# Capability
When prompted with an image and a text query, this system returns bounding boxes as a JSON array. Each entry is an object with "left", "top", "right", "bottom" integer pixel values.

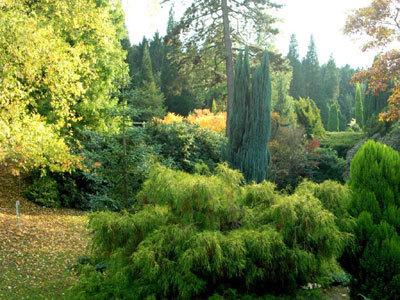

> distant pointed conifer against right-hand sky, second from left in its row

[{"left": 303, "top": 35, "right": 328, "bottom": 125}]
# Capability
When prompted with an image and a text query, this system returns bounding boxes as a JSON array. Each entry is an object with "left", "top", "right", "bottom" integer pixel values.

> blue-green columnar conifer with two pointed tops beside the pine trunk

[{"left": 228, "top": 47, "right": 271, "bottom": 182}]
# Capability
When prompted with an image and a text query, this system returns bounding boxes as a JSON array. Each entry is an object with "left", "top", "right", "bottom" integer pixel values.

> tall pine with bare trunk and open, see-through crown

[{"left": 162, "top": 0, "right": 280, "bottom": 134}]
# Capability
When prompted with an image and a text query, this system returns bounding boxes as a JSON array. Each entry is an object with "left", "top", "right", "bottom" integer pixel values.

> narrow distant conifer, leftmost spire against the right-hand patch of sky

[{"left": 287, "top": 34, "right": 305, "bottom": 99}]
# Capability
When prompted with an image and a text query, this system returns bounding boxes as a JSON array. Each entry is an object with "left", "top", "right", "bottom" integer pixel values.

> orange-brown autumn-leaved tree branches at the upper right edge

[{"left": 344, "top": 0, "right": 400, "bottom": 121}]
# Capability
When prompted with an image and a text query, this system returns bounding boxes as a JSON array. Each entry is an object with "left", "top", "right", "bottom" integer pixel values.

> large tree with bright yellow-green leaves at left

[{"left": 0, "top": 0, "right": 127, "bottom": 173}]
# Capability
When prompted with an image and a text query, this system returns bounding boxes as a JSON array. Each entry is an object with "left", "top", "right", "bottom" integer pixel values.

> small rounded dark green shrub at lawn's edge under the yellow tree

[{"left": 25, "top": 176, "right": 61, "bottom": 207}]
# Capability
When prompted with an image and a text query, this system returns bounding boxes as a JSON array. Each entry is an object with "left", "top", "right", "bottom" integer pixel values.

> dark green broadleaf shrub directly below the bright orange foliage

[{"left": 146, "top": 122, "right": 226, "bottom": 173}]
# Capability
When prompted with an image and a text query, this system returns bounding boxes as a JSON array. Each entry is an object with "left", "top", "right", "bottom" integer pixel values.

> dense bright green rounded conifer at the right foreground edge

[{"left": 342, "top": 141, "right": 400, "bottom": 299}]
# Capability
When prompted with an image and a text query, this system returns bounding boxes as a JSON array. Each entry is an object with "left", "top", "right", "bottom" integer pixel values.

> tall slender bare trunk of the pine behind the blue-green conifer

[{"left": 221, "top": 0, "right": 234, "bottom": 138}]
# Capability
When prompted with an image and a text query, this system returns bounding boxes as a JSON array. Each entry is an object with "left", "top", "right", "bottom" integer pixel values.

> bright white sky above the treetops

[{"left": 123, "top": 0, "right": 377, "bottom": 68}]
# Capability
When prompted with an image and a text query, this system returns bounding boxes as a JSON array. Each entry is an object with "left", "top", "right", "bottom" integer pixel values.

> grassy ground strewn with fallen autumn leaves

[{"left": 0, "top": 169, "right": 89, "bottom": 300}]
